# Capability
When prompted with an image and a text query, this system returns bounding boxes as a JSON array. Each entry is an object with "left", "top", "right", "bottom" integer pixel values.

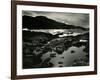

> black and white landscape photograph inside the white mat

[{"left": 22, "top": 10, "right": 90, "bottom": 69}]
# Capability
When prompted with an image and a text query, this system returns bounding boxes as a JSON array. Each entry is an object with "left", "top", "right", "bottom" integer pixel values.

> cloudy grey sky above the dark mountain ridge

[{"left": 22, "top": 11, "right": 89, "bottom": 28}]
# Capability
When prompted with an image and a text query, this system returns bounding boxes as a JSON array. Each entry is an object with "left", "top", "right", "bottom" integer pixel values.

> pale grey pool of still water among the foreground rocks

[{"left": 41, "top": 46, "right": 87, "bottom": 67}]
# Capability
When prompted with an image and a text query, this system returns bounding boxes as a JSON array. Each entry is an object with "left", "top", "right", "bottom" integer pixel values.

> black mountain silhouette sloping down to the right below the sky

[{"left": 22, "top": 15, "right": 87, "bottom": 30}]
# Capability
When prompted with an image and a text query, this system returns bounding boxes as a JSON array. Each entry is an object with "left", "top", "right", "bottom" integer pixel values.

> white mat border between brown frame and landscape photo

[{"left": 17, "top": 5, "right": 94, "bottom": 75}]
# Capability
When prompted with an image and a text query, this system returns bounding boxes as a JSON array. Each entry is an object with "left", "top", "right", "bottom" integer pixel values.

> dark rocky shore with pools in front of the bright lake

[{"left": 23, "top": 31, "right": 89, "bottom": 68}]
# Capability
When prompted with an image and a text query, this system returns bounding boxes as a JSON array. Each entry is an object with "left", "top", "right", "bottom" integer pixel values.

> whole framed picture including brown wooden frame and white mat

[{"left": 11, "top": 1, "right": 97, "bottom": 79}]
